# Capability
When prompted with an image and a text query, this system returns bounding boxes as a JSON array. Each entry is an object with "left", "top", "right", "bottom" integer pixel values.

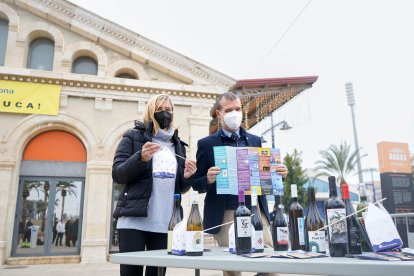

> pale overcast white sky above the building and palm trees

[{"left": 71, "top": 0, "right": 414, "bottom": 184}]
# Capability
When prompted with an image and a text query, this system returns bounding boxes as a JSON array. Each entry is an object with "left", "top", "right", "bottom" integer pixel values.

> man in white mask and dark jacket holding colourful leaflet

[{"left": 193, "top": 92, "right": 287, "bottom": 276}]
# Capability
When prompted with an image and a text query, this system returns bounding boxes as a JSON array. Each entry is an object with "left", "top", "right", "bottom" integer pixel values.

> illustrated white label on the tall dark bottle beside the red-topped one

[{"left": 326, "top": 208, "right": 348, "bottom": 243}]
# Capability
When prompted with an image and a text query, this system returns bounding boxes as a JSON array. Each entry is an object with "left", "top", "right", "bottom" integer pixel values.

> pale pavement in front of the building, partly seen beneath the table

[{"left": 0, "top": 262, "right": 310, "bottom": 276}]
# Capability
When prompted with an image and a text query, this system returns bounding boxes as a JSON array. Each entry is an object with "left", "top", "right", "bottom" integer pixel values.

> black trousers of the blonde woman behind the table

[{"left": 118, "top": 229, "right": 168, "bottom": 276}]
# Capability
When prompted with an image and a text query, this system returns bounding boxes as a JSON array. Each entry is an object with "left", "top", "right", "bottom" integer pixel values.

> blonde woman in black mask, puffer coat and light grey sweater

[{"left": 112, "top": 94, "right": 197, "bottom": 276}]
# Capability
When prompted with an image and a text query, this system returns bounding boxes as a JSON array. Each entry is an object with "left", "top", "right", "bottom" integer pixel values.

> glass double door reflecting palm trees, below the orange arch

[{"left": 12, "top": 177, "right": 84, "bottom": 256}]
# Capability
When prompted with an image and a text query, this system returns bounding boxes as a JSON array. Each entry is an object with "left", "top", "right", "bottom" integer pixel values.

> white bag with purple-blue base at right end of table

[{"left": 365, "top": 203, "right": 403, "bottom": 252}]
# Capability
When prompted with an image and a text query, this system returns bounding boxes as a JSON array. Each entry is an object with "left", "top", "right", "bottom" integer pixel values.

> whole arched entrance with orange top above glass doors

[{"left": 11, "top": 130, "right": 87, "bottom": 257}]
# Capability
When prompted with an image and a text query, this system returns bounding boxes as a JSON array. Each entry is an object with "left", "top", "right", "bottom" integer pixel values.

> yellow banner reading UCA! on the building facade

[{"left": 0, "top": 81, "right": 60, "bottom": 115}]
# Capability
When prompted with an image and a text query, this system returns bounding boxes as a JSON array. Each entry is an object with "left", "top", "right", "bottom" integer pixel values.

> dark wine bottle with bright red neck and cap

[{"left": 341, "top": 183, "right": 362, "bottom": 254}]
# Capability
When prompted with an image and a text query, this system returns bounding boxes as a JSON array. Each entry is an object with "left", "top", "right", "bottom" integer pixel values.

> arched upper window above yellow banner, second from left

[{"left": 27, "top": 38, "right": 55, "bottom": 71}]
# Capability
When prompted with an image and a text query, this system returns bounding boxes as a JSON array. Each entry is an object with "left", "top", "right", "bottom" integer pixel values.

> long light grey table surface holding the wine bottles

[{"left": 111, "top": 248, "right": 414, "bottom": 276}]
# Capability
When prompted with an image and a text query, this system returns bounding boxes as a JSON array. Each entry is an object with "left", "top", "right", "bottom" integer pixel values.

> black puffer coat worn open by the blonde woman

[{"left": 112, "top": 121, "right": 192, "bottom": 218}]
